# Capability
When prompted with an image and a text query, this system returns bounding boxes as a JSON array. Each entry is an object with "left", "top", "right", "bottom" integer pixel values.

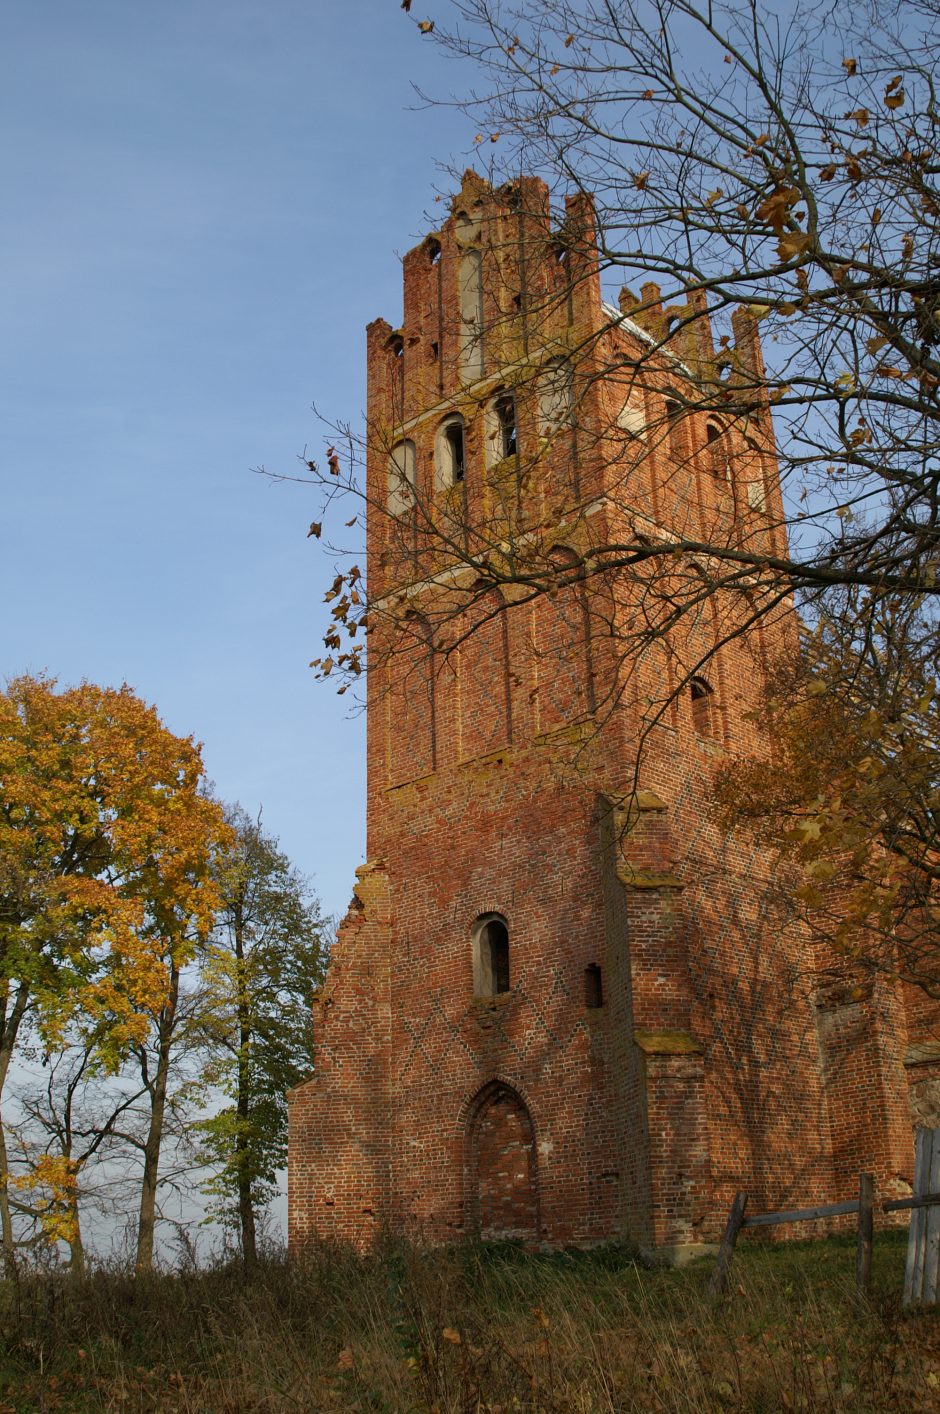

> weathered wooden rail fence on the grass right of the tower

[{"left": 711, "top": 1128, "right": 940, "bottom": 1302}]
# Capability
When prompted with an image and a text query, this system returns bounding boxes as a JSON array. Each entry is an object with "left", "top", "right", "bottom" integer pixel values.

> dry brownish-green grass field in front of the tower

[{"left": 0, "top": 1233, "right": 940, "bottom": 1414}]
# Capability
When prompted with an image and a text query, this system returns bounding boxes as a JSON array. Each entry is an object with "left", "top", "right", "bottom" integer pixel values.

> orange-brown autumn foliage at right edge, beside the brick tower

[{"left": 715, "top": 598, "right": 940, "bottom": 998}]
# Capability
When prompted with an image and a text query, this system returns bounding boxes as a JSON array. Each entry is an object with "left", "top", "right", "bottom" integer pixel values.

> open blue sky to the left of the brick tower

[{"left": 0, "top": 0, "right": 472, "bottom": 913}]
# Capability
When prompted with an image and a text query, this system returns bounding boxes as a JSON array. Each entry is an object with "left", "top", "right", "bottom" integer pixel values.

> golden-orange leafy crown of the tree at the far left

[{"left": 0, "top": 676, "right": 228, "bottom": 1270}]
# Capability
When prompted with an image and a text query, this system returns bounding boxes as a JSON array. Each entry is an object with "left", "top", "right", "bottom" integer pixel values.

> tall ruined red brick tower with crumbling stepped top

[{"left": 290, "top": 173, "right": 932, "bottom": 1251}]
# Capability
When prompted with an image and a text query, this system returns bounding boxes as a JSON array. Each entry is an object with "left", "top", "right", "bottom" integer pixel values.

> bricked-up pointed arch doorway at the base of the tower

[{"left": 468, "top": 1080, "right": 539, "bottom": 1241}]
